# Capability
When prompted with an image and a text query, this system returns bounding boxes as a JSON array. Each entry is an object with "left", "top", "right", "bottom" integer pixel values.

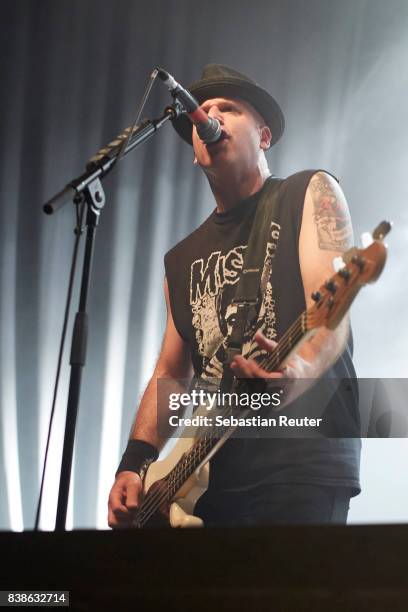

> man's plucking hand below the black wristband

[{"left": 108, "top": 471, "right": 143, "bottom": 529}]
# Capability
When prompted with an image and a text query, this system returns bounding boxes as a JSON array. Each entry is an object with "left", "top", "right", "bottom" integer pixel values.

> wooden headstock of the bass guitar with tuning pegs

[{"left": 306, "top": 221, "right": 391, "bottom": 330}]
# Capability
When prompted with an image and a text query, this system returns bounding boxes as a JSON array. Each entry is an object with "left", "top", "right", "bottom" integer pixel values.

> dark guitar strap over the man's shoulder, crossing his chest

[{"left": 220, "top": 177, "right": 282, "bottom": 393}]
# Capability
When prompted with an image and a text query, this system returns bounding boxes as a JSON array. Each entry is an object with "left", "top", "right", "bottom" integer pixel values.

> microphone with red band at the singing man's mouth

[{"left": 157, "top": 68, "right": 222, "bottom": 144}]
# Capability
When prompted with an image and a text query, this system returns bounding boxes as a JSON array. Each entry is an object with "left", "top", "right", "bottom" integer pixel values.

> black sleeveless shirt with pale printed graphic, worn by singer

[{"left": 165, "top": 170, "right": 361, "bottom": 494}]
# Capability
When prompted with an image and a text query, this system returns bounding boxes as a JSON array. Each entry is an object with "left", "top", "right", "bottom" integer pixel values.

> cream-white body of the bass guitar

[{"left": 144, "top": 438, "right": 209, "bottom": 527}]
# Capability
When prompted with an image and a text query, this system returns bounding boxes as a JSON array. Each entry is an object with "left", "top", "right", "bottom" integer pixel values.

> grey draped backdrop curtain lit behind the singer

[{"left": 0, "top": 0, "right": 408, "bottom": 529}]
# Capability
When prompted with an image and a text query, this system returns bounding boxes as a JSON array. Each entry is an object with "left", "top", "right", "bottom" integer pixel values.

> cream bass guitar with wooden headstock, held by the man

[{"left": 134, "top": 221, "right": 391, "bottom": 528}]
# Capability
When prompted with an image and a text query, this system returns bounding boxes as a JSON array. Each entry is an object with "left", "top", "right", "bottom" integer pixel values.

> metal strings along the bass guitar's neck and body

[{"left": 137, "top": 311, "right": 307, "bottom": 522}]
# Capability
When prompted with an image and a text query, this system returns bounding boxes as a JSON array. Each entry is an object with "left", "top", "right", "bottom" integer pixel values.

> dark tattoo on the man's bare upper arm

[{"left": 309, "top": 173, "right": 353, "bottom": 251}]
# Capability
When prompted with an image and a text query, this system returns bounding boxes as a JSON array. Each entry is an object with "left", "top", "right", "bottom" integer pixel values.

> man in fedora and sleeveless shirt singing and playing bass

[{"left": 108, "top": 64, "right": 360, "bottom": 528}]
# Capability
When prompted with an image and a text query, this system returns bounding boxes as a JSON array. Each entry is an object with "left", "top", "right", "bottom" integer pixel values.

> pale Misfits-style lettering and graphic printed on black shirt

[{"left": 190, "top": 222, "right": 280, "bottom": 378}]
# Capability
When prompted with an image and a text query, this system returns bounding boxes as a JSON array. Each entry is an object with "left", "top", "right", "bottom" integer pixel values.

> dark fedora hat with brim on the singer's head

[{"left": 173, "top": 64, "right": 285, "bottom": 146}]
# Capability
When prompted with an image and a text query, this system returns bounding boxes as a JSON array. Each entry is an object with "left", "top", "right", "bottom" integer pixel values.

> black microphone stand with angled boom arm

[{"left": 43, "top": 100, "right": 184, "bottom": 531}]
